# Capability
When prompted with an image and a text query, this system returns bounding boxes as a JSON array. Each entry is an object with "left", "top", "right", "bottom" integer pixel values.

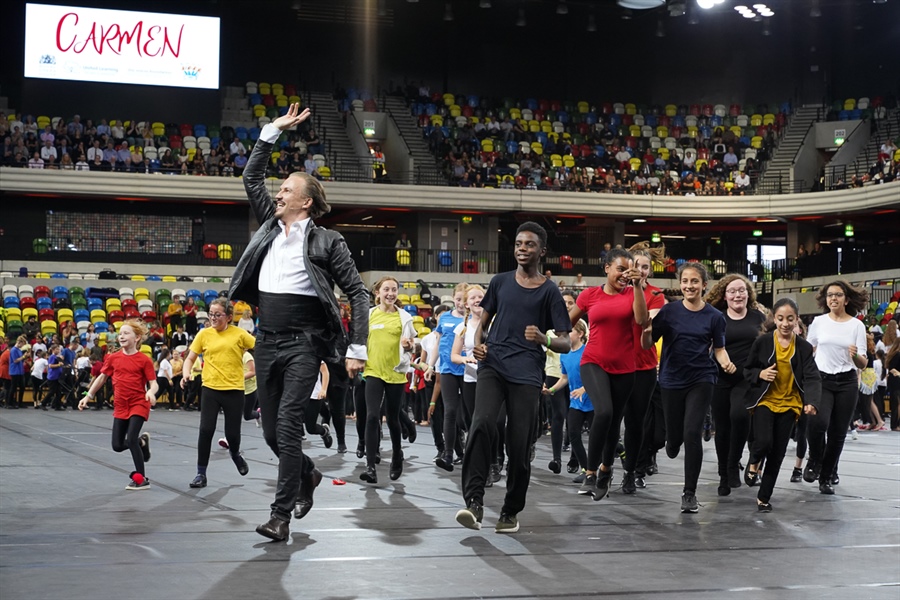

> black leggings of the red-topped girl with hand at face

[{"left": 581, "top": 363, "right": 634, "bottom": 471}]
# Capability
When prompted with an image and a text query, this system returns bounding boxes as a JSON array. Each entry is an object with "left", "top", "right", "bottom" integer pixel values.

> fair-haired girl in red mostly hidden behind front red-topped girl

[{"left": 622, "top": 242, "right": 666, "bottom": 494}]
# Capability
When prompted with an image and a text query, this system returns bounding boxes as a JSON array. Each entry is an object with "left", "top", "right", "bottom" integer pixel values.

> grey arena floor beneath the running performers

[{"left": 0, "top": 408, "right": 900, "bottom": 600}]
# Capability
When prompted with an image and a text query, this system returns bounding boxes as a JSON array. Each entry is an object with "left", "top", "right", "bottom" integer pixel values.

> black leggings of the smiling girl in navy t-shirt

[{"left": 662, "top": 383, "right": 713, "bottom": 492}]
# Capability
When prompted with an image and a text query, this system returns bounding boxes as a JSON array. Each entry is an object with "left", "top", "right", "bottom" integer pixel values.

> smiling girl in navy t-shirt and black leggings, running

[{"left": 641, "top": 262, "right": 737, "bottom": 513}]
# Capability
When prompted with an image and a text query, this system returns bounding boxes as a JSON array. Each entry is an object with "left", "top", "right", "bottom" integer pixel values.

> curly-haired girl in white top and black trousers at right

[{"left": 803, "top": 280, "right": 869, "bottom": 494}]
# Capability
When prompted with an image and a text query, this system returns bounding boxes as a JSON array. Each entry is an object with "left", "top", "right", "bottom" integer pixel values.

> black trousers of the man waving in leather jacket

[{"left": 254, "top": 331, "right": 325, "bottom": 521}]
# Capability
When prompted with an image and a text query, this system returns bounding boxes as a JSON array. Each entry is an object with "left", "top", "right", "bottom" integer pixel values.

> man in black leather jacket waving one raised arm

[{"left": 229, "top": 104, "right": 369, "bottom": 541}]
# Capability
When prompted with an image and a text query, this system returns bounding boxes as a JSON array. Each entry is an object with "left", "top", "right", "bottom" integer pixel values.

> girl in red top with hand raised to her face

[{"left": 569, "top": 248, "right": 648, "bottom": 500}]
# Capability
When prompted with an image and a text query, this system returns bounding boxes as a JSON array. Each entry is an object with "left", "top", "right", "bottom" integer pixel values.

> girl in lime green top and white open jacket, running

[{"left": 357, "top": 277, "right": 416, "bottom": 483}]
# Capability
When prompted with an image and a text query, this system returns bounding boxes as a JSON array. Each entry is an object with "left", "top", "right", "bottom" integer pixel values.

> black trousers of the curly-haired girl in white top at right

[{"left": 809, "top": 373, "right": 858, "bottom": 483}]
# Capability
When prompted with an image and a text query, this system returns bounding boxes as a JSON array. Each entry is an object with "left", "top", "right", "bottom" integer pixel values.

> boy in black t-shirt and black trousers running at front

[{"left": 456, "top": 221, "right": 572, "bottom": 533}]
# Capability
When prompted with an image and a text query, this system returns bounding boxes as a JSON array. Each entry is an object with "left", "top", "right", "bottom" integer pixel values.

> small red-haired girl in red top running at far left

[{"left": 78, "top": 319, "right": 159, "bottom": 490}]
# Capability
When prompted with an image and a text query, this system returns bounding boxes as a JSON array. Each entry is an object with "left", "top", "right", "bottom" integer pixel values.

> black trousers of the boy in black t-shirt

[{"left": 462, "top": 366, "right": 541, "bottom": 515}]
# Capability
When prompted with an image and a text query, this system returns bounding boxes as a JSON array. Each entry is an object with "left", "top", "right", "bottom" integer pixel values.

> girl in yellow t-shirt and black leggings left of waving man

[{"left": 181, "top": 298, "right": 256, "bottom": 488}]
